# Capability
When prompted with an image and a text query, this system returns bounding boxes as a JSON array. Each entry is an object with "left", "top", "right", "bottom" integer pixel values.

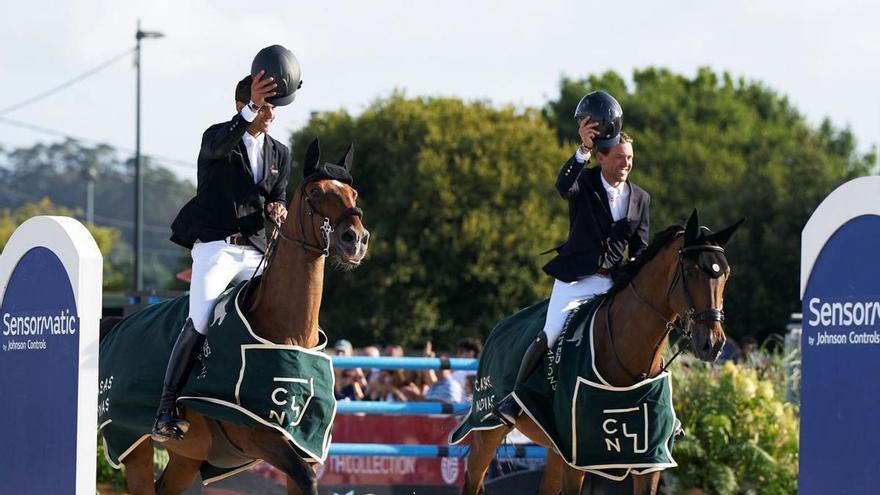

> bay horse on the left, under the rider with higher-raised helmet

[{"left": 102, "top": 140, "right": 369, "bottom": 495}]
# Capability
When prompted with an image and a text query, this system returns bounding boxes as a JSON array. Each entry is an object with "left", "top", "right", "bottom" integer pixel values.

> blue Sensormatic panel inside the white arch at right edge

[{"left": 798, "top": 215, "right": 880, "bottom": 495}]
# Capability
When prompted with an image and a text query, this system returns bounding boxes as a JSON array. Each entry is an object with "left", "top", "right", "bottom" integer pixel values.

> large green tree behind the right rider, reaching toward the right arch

[{"left": 543, "top": 68, "right": 873, "bottom": 337}]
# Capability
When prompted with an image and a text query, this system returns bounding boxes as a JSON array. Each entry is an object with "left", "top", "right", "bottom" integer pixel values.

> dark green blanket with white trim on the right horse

[{"left": 450, "top": 297, "right": 679, "bottom": 480}]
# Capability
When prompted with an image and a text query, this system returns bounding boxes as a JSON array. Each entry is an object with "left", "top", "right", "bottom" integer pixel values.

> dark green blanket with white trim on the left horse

[{"left": 98, "top": 283, "right": 336, "bottom": 480}]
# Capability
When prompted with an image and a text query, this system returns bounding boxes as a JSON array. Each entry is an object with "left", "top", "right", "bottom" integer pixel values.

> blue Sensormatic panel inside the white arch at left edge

[{"left": 0, "top": 247, "right": 80, "bottom": 495}]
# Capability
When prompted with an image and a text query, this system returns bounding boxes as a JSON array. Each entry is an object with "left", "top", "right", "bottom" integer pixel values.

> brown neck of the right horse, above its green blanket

[{"left": 593, "top": 240, "right": 680, "bottom": 386}]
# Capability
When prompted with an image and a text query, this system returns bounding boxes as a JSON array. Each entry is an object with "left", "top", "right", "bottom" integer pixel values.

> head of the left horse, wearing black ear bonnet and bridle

[{"left": 281, "top": 139, "right": 370, "bottom": 268}]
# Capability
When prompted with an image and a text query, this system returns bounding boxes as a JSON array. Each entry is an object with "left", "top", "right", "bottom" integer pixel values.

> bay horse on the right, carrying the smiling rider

[{"left": 462, "top": 210, "right": 743, "bottom": 495}]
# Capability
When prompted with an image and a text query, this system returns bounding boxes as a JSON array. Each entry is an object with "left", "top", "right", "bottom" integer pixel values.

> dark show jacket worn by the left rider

[{"left": 171, "top": 113, "right": 290, "bottom": 251}]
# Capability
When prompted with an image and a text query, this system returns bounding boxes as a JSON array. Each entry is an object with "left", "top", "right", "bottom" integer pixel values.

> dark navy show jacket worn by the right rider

[{"left": 544, "top": 156, "right": 651, "bottom": 282}]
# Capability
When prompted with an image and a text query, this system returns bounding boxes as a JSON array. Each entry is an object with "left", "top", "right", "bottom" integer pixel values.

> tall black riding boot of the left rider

[{"left": 150, "top": 318, "right": 205, "bottom": 442}]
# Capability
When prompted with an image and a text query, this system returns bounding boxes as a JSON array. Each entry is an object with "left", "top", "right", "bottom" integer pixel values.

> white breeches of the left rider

[{"left": 189, "top": 240, "right": 263, "bottom": 335}]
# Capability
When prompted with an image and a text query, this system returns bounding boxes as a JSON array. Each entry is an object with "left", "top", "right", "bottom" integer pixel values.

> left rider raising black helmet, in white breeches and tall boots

[{"left": 151, "top": 45, "right": 301, "bottom": 442}]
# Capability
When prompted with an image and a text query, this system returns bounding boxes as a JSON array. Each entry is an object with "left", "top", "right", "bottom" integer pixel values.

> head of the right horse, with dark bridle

[{"left": 670, "top": 210, "right": 743, "bottom": 361}]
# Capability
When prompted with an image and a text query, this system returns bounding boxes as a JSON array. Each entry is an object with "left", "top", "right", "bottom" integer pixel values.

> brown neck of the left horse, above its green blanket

[{"left": 248, "top": 203, "right": 324, "bottom": 348}]
